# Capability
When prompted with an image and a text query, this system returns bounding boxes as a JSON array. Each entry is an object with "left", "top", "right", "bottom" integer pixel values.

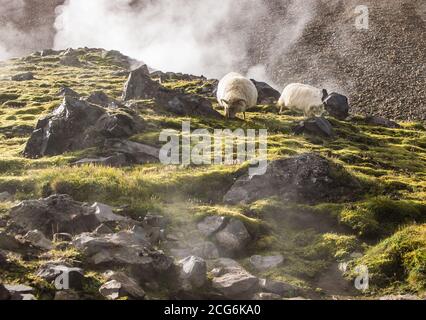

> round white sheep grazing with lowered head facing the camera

[{"left": 217, "top": 72, "right": 258, "bottom": 120}]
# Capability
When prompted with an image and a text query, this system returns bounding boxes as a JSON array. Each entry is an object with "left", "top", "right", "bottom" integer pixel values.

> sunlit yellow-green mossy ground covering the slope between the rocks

[{"left": 0, "top": 50, "right": 426, "bottom": 294}]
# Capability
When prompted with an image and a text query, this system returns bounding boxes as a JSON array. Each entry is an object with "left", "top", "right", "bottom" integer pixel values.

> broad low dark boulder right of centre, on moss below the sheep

[{"left": 224, "top": 153, "right": 360, "bottom": 204}]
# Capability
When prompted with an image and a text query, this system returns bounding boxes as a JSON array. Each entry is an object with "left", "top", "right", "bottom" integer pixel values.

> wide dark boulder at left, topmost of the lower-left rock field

[{"left": 10, "top": 195, "right": 101, "bottom": 239}]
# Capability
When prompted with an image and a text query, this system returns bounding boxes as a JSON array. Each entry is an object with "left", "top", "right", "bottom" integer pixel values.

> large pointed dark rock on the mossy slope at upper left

[{"left": 24, "top": 96, "right": 143, "bottom": 158}]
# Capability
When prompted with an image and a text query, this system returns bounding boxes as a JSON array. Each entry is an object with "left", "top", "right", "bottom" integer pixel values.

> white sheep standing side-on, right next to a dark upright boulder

[{"left": 278, "top": 83, "right": 328, "bottom": 117}]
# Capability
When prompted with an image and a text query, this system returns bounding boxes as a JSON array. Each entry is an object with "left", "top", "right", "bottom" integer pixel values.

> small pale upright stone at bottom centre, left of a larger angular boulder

[{"left": 179, "top": 256, "right": 207, "bottom": 289}]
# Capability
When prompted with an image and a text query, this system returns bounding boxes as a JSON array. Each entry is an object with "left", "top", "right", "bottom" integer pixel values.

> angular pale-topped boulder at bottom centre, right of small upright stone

[{"left": 212, "top": 259, "right": 259, "bottom": 299}]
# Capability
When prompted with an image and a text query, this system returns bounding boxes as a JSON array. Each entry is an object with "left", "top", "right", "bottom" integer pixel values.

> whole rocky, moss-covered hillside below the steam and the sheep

[{"left": 0, "top": 48, "right": 426, "bottom": 299}]
